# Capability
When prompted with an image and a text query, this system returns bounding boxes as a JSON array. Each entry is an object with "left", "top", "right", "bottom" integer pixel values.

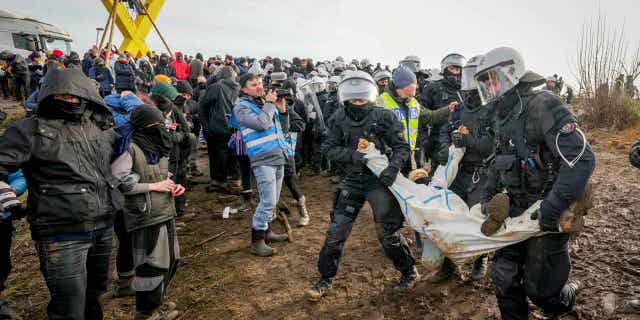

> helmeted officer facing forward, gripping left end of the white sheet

[{"left": 306, "top": 71, "right": 420, "bottom": 301}]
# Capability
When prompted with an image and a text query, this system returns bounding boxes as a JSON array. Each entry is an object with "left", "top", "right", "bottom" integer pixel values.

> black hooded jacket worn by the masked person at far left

[{"left": 0, "top": 68, "right": 123, "bottom": 239}]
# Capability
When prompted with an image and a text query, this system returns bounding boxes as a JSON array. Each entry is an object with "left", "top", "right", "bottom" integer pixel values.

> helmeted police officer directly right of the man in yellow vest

[{"left": 421, "top": 53, "right": 466, "bottom": 173}]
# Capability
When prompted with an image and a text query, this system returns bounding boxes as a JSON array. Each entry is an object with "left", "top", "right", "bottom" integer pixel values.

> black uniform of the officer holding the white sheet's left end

[{"left": 318, "top": 107, "right": 415, "bottom": 281}]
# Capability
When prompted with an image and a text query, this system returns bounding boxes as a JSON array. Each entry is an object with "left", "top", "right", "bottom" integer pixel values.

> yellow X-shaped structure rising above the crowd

[{"left": 101, "top": 0, "right": 164, "bottom": 58}]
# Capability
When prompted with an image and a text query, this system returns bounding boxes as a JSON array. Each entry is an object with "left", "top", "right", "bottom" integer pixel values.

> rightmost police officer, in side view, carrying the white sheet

[{"left": 475, "top": 47, "right": 595, "bottom": 320}]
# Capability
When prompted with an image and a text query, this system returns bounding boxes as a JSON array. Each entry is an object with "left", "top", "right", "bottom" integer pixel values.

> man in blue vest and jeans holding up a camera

[{"left": 230, "top": 74, "right": 293, "bottom": 257}]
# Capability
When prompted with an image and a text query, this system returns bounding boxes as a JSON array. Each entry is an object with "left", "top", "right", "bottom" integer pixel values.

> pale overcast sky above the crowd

[{"left": 2, "top": 0, "right": 640, "bottom": 85}]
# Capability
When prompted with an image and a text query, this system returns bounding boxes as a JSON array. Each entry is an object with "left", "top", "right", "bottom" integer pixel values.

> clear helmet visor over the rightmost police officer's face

[{"left": 475, "top": 65, "right": 517, "bottom": 105}]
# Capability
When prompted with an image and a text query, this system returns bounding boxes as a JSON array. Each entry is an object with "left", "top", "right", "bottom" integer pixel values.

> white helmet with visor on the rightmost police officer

[{"left": 475, "top": 47, "right": 544, "bottom": 104}]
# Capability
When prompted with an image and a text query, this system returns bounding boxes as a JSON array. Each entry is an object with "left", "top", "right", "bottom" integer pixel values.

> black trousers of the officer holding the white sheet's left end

[{"left": 318, "top": 175, "right": 415, "bottom": 281}]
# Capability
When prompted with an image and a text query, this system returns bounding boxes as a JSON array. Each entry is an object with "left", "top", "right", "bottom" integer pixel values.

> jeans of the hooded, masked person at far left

[{"left": 36, "top": 228, "right": 113, "bottom": 320}]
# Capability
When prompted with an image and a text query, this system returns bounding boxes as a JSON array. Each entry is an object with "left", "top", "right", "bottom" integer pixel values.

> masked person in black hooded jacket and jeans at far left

[{"left": 0, "top": 68, "right": 123, "bottom": 319}]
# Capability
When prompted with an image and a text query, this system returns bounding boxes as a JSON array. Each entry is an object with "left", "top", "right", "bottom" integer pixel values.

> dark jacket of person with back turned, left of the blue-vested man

[{"left": 200, "top": 79, "right": 240, "bottom": 134}]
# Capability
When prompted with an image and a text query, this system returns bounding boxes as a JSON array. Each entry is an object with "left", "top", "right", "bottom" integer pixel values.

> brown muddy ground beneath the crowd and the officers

[{"left": 0, "top": 98, "right": 640, "bottom": 320}]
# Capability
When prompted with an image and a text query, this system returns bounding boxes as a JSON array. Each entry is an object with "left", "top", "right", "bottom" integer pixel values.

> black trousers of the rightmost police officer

[{"left": 492, "top": 234, "right": 571, "bottom": 320}]
